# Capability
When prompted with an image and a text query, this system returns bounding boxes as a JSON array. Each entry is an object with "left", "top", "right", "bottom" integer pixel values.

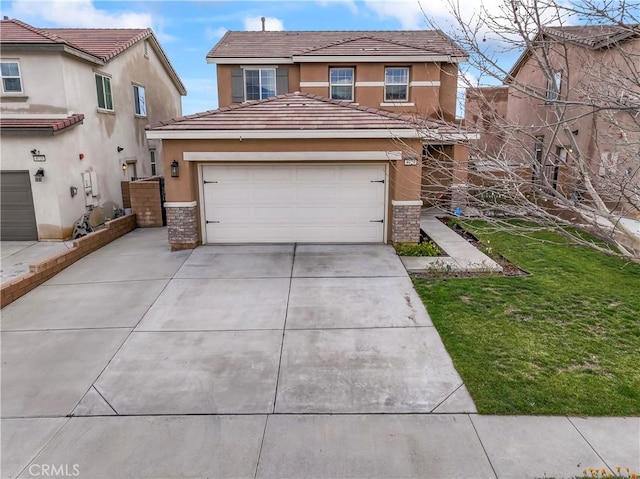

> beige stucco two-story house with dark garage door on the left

[{"left": 0, "top": 18, "right": 186, "bottom": 240}]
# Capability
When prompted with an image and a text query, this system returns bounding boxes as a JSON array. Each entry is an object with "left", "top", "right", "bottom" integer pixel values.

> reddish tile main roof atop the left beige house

[{"left": 0, "top": 19, "right": 153, "bottom": 62}]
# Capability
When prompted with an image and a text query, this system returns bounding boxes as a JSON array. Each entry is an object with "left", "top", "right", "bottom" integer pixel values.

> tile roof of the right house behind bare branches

[{"left": 541, "top": 25, "right": 640, "bottom": 49}]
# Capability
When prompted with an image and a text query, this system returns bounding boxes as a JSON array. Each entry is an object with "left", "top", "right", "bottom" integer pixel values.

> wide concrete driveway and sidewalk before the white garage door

[{"left": 1, "top": 229, "right": 637, "bottom": 478}]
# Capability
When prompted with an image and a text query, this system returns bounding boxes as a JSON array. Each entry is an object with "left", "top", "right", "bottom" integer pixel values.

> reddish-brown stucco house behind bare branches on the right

[{"left": 466, "top": 25, "right": 640, "bottom": 215}]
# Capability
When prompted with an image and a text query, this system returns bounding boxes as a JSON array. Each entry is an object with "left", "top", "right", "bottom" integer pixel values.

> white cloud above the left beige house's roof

[{"left": 11, "top": 0, "right": 153, "bottom": 28}]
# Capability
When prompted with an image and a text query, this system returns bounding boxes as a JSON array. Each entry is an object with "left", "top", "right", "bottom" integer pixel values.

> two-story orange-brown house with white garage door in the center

[{"left": 147, "top": 31, "right": 467, "bottom": 249}]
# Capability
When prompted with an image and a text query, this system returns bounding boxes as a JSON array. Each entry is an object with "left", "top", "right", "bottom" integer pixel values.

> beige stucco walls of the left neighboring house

[{"left": 0, "top": 38, "right": 181, "bottom": 239}]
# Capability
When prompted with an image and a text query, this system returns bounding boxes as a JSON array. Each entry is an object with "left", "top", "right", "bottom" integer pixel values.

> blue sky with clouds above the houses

[{"left": 5, "top": 0, "right": 540, "bottom": 115}]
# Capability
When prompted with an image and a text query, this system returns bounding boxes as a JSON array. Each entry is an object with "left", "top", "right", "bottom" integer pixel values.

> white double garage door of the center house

[{"left": 202, "top": 164, "right": 386, "bottom": 243}]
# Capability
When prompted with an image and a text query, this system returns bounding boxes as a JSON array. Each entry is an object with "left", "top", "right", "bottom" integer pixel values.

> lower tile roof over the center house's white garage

[{"left": 147, "top": 92, "right": 460, "bottom": 138}]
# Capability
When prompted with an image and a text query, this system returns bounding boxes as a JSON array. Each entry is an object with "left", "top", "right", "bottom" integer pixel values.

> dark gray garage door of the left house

[{"left": 0, "top": 171, "right": 38, "bottom": 241}]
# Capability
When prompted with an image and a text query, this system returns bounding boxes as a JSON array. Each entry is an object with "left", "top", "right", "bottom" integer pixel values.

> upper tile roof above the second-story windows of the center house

[{"left": 207, "top": 30, "right": 467, "bottom": 59}]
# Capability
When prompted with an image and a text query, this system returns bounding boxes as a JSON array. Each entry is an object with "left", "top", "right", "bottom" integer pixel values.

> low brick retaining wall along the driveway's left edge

[{"left": 0, "top": 215, "right": 136, "bottom": 308}]
